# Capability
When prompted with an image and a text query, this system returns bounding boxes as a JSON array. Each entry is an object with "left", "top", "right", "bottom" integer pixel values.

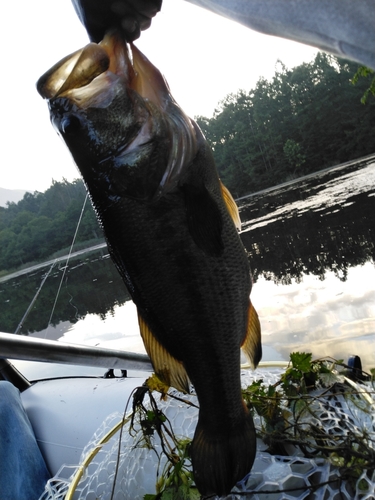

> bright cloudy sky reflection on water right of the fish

[{"left": 253, "top": 262, "right": 375, "bottom": 369}]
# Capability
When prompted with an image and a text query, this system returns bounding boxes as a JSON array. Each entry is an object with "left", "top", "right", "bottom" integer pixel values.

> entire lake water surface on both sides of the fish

[{"left": 0, "top": 156, "right": 375, "bottom": 370}]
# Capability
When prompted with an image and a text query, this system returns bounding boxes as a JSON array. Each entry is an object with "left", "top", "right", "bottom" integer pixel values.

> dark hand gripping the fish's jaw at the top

[{"left": 72, "top": 0, "right": 162, "bottom": 43}]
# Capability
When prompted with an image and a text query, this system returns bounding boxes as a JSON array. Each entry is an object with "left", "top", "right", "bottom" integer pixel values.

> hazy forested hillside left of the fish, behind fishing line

[{"left": 0, "top": 179, "right": 103, "bottom": 270}]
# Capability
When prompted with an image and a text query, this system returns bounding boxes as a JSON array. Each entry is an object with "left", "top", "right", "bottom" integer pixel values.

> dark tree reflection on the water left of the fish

[{"left": 0, "top": 254, "right": 130, "bottom": 338}]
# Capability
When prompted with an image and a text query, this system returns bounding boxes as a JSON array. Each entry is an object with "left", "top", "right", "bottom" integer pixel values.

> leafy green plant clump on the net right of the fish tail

[{"left": 243, "top": 352, "right": 375, "bottom": 484}]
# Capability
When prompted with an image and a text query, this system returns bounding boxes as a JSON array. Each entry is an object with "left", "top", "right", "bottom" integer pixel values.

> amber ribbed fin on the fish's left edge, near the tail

[{"left": 138, "top": 311, "right": 190, "bottom": 393}]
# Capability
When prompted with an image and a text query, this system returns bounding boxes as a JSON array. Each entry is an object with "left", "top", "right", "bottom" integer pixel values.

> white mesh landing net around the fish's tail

[{"left": 40, "top": 369, "right": 375, "bottom": 500}]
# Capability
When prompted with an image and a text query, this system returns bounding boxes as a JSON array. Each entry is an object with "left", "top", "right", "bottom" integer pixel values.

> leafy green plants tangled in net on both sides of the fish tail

[{"left": 130, "top": 352, "right": 375, "bottom": 500}]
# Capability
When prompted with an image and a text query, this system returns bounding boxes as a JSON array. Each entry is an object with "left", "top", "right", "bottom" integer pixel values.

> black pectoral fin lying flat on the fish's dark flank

[{"left": 181, "top": 183, "right": 224, "bottom": 255}]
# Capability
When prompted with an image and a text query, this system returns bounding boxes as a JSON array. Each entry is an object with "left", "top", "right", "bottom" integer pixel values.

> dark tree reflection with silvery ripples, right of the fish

[{"left": 241, "top": 159, "right": 375, "bottom": 284}]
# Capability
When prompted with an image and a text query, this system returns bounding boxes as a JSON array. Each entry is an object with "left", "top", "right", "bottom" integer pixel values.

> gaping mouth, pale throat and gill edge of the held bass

[{"left": 36, "top": 32, "right": 200, "bottom": 199}]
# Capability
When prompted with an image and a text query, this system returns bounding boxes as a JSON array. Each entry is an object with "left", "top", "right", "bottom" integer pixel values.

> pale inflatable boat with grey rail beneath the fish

[{"left": 0, "top": 334, "right": 375, "bottom": 500}]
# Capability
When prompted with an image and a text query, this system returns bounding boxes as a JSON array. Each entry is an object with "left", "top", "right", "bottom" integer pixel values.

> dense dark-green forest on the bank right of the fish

[{"left": 196, "top": 53, "right": 375, "bottom": 197}]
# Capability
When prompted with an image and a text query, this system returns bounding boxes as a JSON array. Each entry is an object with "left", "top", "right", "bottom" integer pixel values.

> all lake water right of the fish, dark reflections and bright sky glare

[{"left": 241, "top": 158, "right": 375, "bottom": 369}]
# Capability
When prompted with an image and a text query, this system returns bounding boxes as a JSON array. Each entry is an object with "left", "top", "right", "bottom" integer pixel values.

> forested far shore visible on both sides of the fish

[{"left": 0, "top": 53, "right": 375, "bottom": 273}]
